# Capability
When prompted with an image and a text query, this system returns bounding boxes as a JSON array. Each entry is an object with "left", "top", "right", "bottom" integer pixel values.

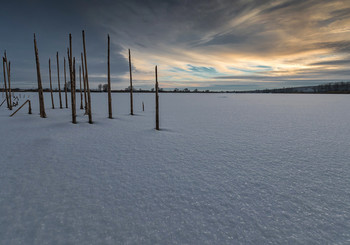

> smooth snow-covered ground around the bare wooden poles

[{"left": 0, "top": 93, "right": 350, "bottom": 244}]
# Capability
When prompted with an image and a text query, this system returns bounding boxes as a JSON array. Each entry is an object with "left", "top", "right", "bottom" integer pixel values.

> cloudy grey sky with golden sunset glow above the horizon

[{"left": 0, "top": 0, "right": 350, "bottom": 90}]
